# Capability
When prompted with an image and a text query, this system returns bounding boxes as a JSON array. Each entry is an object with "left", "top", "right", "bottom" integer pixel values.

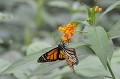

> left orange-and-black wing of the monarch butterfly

[{"left": 37, "top": 47, "right": 65, "bottom": 62}]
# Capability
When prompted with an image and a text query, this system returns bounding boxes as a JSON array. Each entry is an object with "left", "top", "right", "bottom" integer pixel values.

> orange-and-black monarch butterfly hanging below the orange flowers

[{"left": 37, "top": 41, "right": 78, "bottom": 73}]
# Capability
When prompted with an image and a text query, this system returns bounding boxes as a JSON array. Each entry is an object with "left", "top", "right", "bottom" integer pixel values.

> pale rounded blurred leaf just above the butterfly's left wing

[{"left": 27, "top": 42, "right": 51, "bottom": 55}]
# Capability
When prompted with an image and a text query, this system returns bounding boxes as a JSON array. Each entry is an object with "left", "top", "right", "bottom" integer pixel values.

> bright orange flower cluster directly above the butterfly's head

[{"left": 58, "top": 23, "right": 76, "bottom": 41}]
